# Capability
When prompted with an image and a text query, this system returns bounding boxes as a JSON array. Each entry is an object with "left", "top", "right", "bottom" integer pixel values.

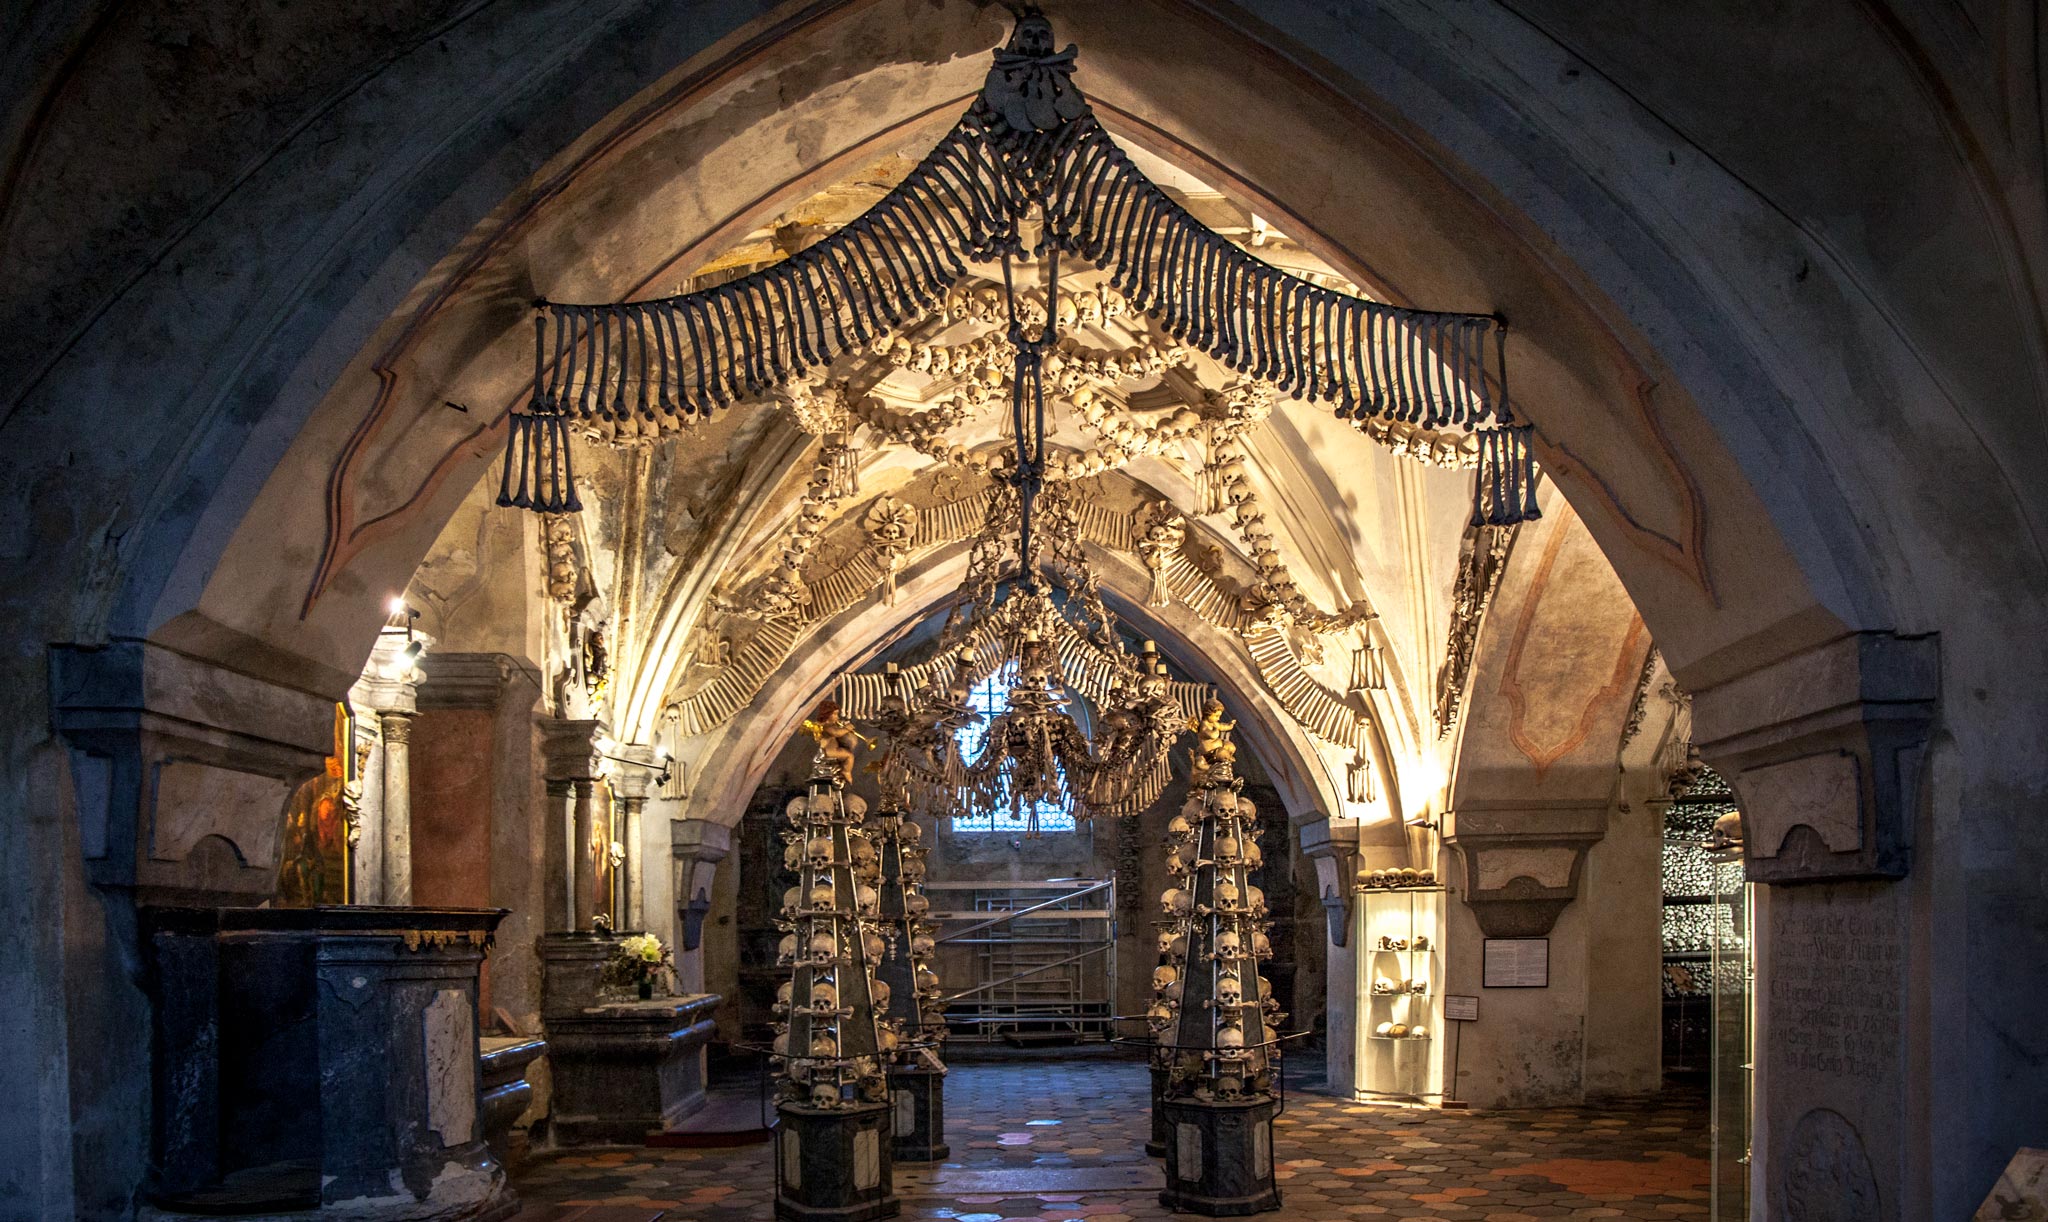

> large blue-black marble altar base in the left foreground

[{"left": 145, "top": 905, "right": 518, "bottom": 1222}]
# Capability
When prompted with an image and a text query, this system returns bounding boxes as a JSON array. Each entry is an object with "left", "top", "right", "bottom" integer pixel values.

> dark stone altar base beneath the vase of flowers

[{"left": 547, "top": 993, "right": 723, "bottom": 1146}]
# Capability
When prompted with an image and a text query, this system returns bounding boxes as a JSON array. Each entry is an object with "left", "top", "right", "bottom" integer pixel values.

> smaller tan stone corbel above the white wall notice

[{"left": 1444, "top": 804, "right": 1608, "bottom": 937}]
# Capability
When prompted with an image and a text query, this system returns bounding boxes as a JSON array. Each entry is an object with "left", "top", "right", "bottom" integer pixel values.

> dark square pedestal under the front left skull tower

[{"left": 774, "top": 1103, "right": 903, "bottom": 1222}]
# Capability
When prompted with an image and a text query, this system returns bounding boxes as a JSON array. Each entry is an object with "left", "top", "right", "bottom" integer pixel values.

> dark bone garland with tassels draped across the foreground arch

[{"left": 498, "top": 14, "right": 1538, "bottom": 524}]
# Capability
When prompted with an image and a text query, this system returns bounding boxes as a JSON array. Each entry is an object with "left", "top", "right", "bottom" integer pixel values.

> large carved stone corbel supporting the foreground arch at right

[{"left": 1692, "top": 632, "right": 1942, "bottom": 884}]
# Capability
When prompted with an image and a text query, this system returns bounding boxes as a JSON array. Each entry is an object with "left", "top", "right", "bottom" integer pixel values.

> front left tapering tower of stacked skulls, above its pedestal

[{"left": 774, "top": 776, "right": 889, "bottom": 1107}]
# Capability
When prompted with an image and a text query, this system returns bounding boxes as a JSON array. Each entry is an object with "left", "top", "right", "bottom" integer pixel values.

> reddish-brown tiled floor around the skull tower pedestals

[{"left": 516, "top": 1060, "right": 1708, "bottom": 1222}]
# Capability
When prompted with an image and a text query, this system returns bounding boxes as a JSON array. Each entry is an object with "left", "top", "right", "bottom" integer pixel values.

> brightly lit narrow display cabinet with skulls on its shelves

[{"left": 1352, "top": 886, "right": 1444, "bottom": 1103}]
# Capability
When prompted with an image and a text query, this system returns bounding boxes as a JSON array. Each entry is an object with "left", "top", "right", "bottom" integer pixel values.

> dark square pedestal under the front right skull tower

[{"left": 1159, "top": 1095, "right": 1280, "bottom": 1218}]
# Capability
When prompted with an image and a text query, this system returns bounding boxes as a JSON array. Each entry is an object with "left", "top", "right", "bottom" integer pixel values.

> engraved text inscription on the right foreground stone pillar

[{"left": 1769, "top": 892, "right": 1901, "bottom": 1083}]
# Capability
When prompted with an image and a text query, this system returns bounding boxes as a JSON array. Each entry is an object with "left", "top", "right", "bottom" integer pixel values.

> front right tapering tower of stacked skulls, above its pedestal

[{"left": 1161, "top": 766, "right": 1286, "bottom": 1101}]
